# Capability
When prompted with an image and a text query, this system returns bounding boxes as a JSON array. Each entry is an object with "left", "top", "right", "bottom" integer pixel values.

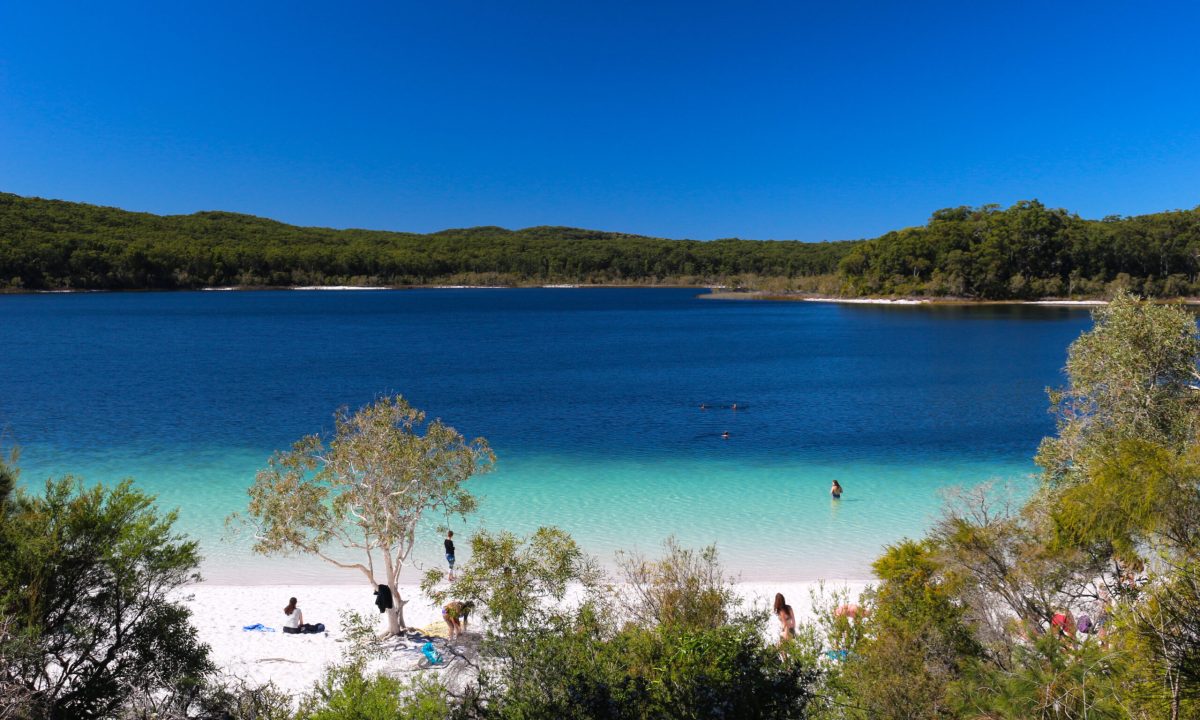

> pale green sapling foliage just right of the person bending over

[{"left": 421, "top": 528, "right": 604, "bottom": 631}]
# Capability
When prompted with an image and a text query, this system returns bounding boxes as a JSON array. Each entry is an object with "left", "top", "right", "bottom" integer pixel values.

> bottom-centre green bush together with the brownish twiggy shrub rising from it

[{"left": 453, "top": 541, "right": 818, "bottom": 719}]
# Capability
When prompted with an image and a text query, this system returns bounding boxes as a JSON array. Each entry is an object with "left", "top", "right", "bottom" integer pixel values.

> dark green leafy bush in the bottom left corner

[{"left": 0, "top": 472, "right": 212, "bottom": 719}]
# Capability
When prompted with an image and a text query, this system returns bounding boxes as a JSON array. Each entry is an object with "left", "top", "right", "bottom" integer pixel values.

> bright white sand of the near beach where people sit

[{"left": 178, "top": 581, "right": 868, "bottom": 696}]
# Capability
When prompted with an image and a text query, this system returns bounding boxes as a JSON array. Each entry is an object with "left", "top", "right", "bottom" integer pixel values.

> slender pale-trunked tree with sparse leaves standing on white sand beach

[{"left": 244, "top": 395, "right": 496, "bottom": 634}]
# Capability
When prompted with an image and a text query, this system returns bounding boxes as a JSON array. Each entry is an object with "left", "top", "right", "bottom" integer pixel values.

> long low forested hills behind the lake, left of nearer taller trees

[{"left": 0, "top": 194, "right": 854, "bottom": 289}]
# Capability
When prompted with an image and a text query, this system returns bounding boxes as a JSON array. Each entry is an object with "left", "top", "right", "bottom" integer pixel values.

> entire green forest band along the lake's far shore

[{"left": 7, "top": 194, "right": 1200, "bottom": 300}]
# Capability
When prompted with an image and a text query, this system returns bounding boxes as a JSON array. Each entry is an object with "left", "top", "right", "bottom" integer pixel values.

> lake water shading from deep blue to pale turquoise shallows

[{"left": 0, "top": 289, "right": 1088, "bottom": 583}]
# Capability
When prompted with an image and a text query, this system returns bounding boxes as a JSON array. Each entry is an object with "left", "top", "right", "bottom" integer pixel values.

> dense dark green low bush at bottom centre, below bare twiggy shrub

[{"left": 479, "top": 609, "right": 816, "bottom": 720}]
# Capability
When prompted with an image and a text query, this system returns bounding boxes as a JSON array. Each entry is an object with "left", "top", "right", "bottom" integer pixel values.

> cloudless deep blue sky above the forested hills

[{"left": 0, "top": 0, "right": 1200, "bottom": 240}]
